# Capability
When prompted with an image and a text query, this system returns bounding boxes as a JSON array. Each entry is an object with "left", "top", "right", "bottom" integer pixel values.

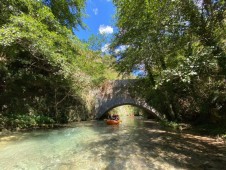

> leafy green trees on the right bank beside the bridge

[{"left": 111, "top": 0, "right": 226, "bottom": 123}]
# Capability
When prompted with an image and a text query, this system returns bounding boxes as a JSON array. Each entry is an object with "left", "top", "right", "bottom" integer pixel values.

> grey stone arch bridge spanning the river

[{"left": 94, "top": 79, "right": 163, "bottom": 119}]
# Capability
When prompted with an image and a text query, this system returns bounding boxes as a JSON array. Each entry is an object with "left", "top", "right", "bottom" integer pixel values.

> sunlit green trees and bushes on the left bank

[{"left": 0, "top": 0, "right": 114, "bottom": 127}]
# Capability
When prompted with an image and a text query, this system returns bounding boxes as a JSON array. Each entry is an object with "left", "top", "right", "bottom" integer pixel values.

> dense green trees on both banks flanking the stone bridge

[{"left": 0, "top": 0, "right": 226, "bottom": 129}]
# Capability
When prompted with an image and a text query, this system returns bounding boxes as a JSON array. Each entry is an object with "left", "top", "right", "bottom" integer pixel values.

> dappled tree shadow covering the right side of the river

[{"left": 90, "top": 120, "right": 226, "bottom": 170}]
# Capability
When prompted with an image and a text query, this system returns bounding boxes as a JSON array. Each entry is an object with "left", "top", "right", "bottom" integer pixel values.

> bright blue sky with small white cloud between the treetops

[{"left": 74, "top": 0, "right": 116, "bottom": 40}]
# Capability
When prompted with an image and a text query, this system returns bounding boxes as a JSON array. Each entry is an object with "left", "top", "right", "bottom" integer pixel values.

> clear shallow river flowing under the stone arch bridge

[{"left": 0, "top": 117, "right": 226, "bottom": 170}]
